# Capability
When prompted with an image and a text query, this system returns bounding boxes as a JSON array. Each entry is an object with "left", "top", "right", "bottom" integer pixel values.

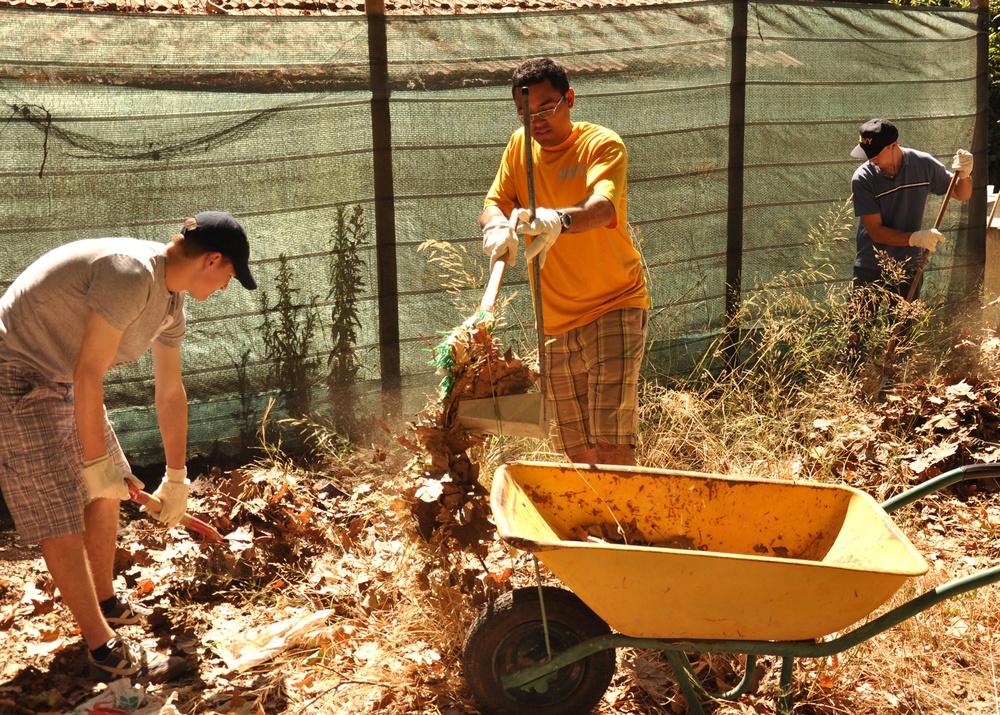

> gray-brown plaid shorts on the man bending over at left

[{"left": 0, "top": 362, "right": 128, "bottom": 543}]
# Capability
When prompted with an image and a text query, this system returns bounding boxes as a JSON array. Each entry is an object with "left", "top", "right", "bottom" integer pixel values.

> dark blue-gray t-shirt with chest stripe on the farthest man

[{"left": 851, "top": 147, "right": 951, "bottom": 270}]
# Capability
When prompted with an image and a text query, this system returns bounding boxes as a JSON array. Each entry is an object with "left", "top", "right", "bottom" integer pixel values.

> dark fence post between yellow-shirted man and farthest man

[{"left": 723, "top": 0, "right": 748, "bottom": 367}]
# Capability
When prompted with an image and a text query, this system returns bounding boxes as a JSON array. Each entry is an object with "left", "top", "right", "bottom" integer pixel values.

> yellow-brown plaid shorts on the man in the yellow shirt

[{"left": 545, "top": 308, "right": 649, "bottom": 454}]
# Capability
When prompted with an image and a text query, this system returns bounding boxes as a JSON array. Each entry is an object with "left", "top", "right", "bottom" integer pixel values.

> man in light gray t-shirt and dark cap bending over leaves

[{"left": 0, "top": 211, "right": 257, "bottom": 682}]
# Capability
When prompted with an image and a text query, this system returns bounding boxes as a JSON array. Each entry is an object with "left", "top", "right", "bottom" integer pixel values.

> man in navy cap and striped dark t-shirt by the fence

[{"left": 851, "top": 119, "right": 973, "bottom": 298}]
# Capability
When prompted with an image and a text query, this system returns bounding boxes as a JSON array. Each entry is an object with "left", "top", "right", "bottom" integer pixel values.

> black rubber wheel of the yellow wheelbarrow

[{"left": 462, "top": 586, "right": 615, "bottom": 715}]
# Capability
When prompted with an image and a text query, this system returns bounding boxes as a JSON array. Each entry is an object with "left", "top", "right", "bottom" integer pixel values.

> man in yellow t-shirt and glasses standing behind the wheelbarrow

[{"left": 479, "top": 58, "right": 649, "bottom": 464}]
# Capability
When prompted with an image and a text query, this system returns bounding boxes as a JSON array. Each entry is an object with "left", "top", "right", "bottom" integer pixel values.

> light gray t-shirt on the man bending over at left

[{"left": 0, "top": 238, "right": 185, "bottom": 383}]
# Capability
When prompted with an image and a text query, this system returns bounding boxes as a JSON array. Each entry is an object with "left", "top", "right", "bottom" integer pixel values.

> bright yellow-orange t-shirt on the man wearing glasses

[{"left": 485, "top": 122, "right": 649, "bottom": 335}]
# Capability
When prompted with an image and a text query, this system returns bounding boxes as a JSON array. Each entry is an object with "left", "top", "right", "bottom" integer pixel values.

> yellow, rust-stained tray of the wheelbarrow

[{"left": 491, "top": 462, "right": 927, "bottom": 641}]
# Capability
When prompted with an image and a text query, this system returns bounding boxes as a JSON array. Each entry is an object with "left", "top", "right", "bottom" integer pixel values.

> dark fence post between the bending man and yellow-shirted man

[{"left": 365, "top": 0, "right": 402, "bottom": 417}]
